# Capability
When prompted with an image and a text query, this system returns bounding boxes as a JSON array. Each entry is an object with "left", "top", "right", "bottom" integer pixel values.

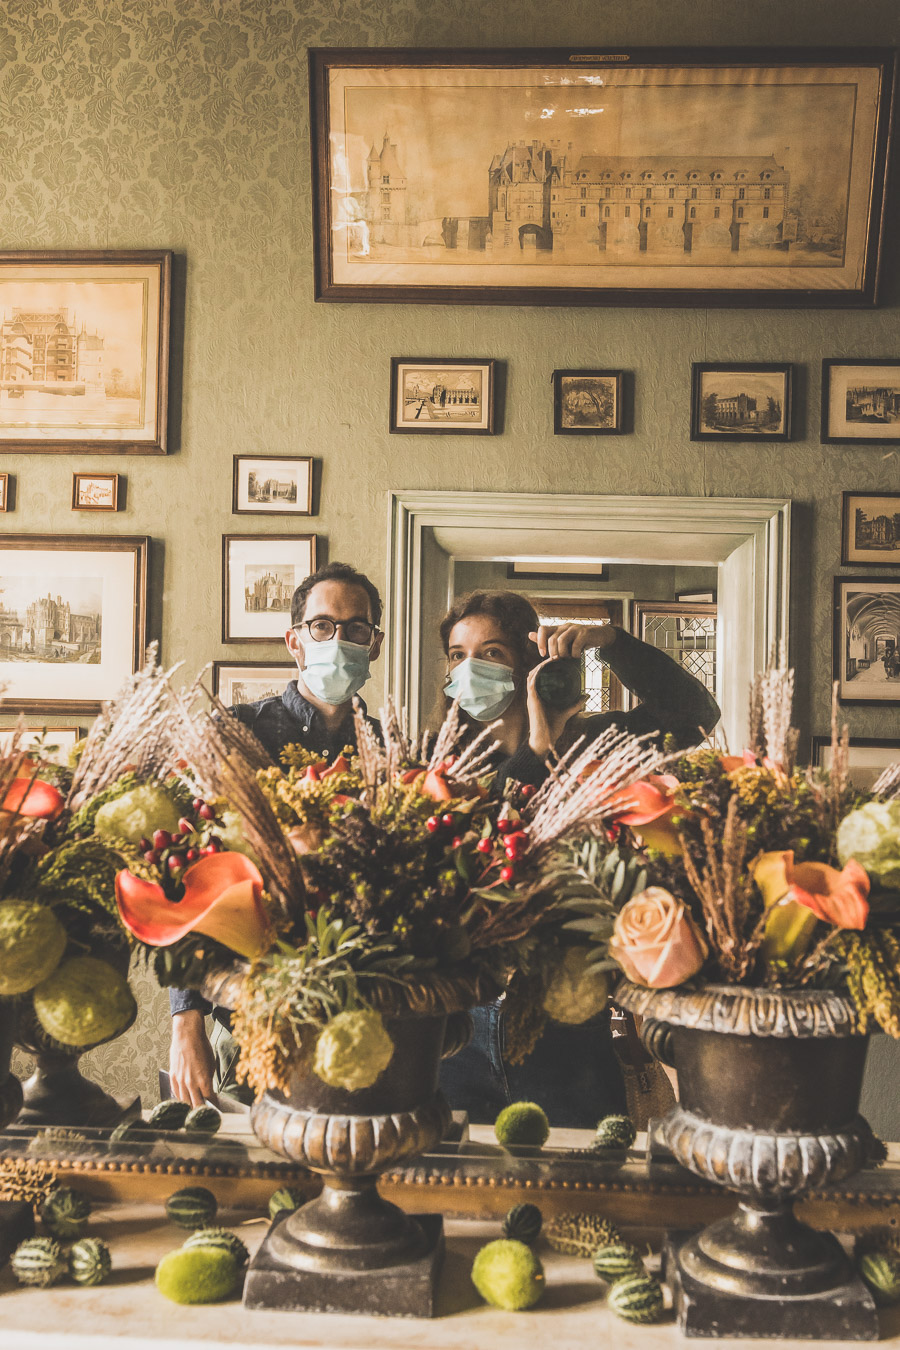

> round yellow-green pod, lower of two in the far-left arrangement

[{"left": 34, "top": 956, "right": 136, "bottom": 1046}]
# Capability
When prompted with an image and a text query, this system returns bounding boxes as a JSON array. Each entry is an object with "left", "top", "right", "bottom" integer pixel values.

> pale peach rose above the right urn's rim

[{"left": 610, "top": 886, "right": 708, "bottom": 990}]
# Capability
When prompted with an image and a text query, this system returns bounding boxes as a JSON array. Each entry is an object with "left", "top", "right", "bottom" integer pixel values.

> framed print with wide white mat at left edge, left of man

[{"left": 0, "top": 535, "right": 150, "bottom": 716}]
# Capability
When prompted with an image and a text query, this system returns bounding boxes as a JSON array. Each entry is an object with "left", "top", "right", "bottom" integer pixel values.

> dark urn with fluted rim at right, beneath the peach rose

[{"left": 615, "top": 983, "right": 878, "bottom": 1341}]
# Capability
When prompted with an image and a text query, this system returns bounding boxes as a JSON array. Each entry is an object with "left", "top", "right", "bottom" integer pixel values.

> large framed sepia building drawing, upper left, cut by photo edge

[{"left": 0, "top": 250, "right": 171, "bottom": 455}]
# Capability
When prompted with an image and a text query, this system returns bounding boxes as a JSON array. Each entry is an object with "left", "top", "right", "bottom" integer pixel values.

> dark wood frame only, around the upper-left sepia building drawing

[{"left": 0, "top": 248, "right": 173, "bottom": 455}]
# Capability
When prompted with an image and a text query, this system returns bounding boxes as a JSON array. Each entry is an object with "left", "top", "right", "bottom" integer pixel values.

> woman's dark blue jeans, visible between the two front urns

[{"left": 440, "top": 1002, "right": 626, "bottom": 1130}]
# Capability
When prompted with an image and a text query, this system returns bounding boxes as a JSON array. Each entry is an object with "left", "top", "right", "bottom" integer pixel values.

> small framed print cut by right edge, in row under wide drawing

[{"left": 820, "top": 358, "right": 900, "bottom": 446}]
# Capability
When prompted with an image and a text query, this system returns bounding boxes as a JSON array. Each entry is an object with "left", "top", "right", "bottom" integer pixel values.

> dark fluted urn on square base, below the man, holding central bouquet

[{"left": 202, "top": 972, "right": 495, "bottom": 1316}]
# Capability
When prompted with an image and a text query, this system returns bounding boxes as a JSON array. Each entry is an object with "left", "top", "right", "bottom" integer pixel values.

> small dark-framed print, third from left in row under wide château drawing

[{"left": 691, "top": 362, "right": 793, "bottom": 440}]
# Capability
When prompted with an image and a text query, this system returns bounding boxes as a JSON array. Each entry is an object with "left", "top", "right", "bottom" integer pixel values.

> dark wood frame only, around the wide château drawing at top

[{"left": 309, "top": 47, "right": 896, "bottom": 309}]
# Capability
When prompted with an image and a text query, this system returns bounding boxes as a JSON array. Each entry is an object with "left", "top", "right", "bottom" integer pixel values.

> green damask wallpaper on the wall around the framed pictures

[{"left": 0, "top": 0, "right": 900, "bottom": 1117}]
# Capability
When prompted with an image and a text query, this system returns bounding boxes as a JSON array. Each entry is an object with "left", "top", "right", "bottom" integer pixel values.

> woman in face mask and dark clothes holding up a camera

[{"left": 431, "top": 591, "right": 719, "bottom": 1129}]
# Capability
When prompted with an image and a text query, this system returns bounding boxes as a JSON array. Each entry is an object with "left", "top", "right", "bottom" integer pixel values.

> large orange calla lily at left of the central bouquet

[{"left": 116, "top": 852, "right": 271, "bottom": 959}]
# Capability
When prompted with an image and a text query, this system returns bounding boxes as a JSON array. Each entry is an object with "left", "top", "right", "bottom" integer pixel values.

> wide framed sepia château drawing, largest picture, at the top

[{"left": 309, "top": 47, "right": 895, "bottom": 308}]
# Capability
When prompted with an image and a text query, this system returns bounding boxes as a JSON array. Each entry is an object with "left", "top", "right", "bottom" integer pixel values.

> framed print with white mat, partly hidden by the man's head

[{"left": 221, "top": 535, "right": 316, "bottom": 643}]
